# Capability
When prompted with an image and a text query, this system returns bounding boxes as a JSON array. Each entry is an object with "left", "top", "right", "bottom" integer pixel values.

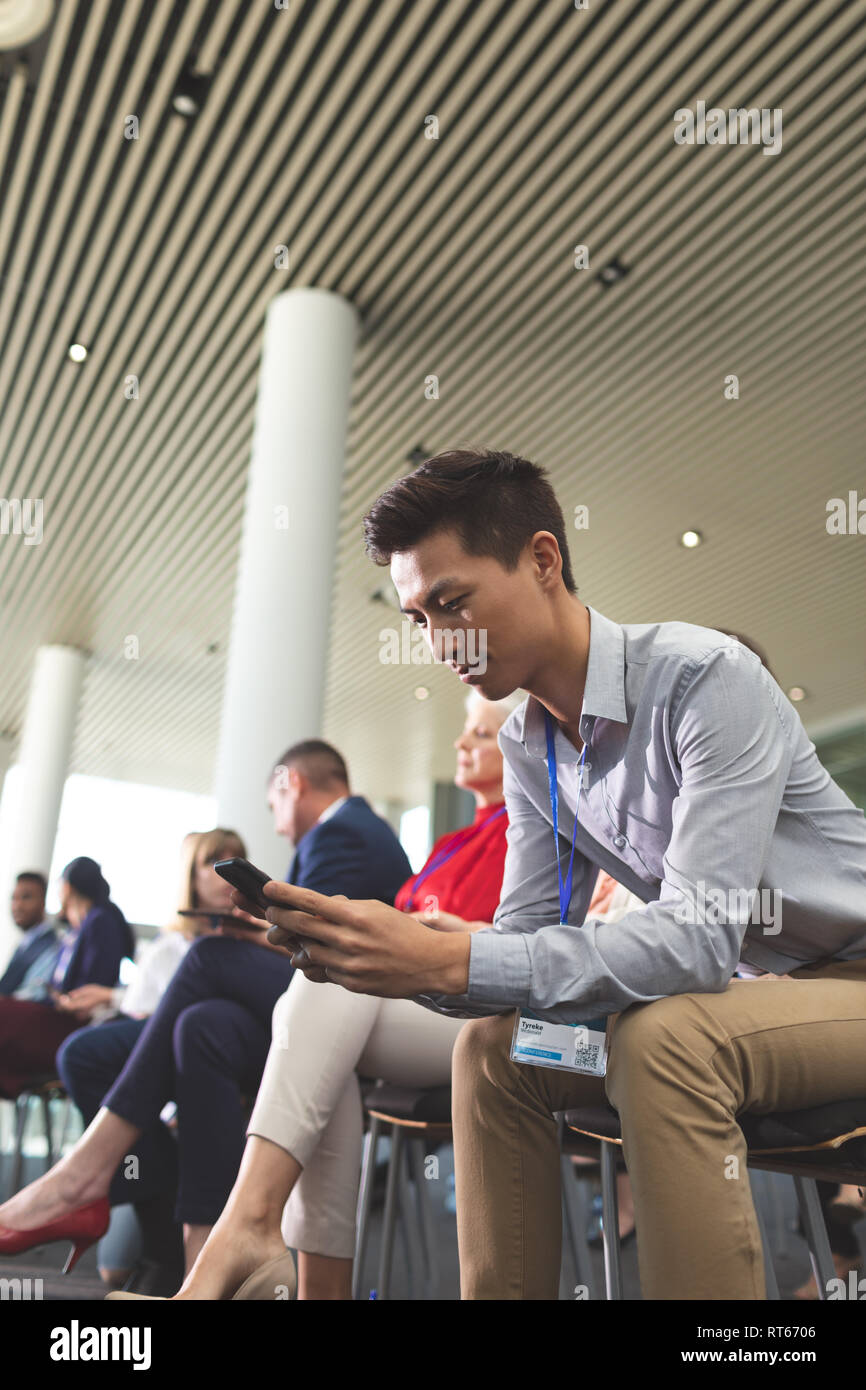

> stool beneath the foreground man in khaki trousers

[{"left": 566, "top": 1098, "right": 866, "bottom": 1300}]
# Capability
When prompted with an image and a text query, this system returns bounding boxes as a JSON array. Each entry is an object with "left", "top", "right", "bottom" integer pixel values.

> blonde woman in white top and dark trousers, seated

[{"left": 57, "top": 827, "right": 246, "bottom": 1289}]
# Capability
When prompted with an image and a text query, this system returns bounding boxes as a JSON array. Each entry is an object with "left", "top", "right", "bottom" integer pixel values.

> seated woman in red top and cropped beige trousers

[{"left": 108, "top": 694, "right": 523, "bottom": 1300}]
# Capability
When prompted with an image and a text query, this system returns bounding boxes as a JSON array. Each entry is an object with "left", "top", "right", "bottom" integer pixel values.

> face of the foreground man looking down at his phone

[{"left": 391, "top": 531, "right": 552, "bottom": 701}]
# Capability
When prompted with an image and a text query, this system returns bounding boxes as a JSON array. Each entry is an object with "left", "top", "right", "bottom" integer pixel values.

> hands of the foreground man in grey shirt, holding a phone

[{"left": 255, "top": 880, "right": 470, "bottom": 999}]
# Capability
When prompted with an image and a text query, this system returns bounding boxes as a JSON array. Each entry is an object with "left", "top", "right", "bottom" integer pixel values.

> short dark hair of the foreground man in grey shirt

[{"left": 364, "top": 448, "right": 577, "bottom": 594}]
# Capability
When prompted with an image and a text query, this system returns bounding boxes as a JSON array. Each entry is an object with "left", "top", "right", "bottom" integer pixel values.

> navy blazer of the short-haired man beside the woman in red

[{"left": 286, "top": 796, "right": 411, "bottom": 905}]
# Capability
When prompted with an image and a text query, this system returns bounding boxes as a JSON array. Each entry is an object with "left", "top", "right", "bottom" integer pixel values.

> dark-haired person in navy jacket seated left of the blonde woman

[{"left": 0, "top": 855, "right": 135, "bottom": 1099}]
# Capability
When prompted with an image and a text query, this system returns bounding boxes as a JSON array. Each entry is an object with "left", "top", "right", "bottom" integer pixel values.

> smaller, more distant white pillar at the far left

[{"left": 0, "top": 646, "right": 85, "bottom": 959}]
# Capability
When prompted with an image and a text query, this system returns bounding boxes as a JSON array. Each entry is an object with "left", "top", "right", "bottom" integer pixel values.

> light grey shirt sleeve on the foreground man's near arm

[{"left": 422, "top": 652, "right": 794, "bottom": 1023}]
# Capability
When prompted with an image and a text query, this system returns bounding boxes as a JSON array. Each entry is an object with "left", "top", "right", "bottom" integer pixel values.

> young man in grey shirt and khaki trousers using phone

[{"left": 254, "top": 450, "right": 866, "bottom": 1300}]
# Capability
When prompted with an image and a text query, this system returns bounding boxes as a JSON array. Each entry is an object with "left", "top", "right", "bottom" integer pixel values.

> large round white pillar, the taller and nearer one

[{"left": 215, "top": 288, "right": 357, "bottom": 877}]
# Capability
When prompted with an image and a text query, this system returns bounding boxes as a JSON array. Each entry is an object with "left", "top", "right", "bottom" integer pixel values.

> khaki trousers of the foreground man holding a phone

[{"left": 453, "top": 956, "right": 866, "bottom": 1300}]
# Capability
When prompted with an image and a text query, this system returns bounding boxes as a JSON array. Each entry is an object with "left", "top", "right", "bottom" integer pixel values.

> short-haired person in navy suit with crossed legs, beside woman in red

[{"left": 0, "top": 738, "right": 410, "bottom": 1269}]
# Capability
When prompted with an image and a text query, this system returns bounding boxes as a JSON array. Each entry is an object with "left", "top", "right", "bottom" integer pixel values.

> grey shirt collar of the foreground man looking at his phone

[{"left": 520, "top": 605, "right": 628, "bottom": 762}]
